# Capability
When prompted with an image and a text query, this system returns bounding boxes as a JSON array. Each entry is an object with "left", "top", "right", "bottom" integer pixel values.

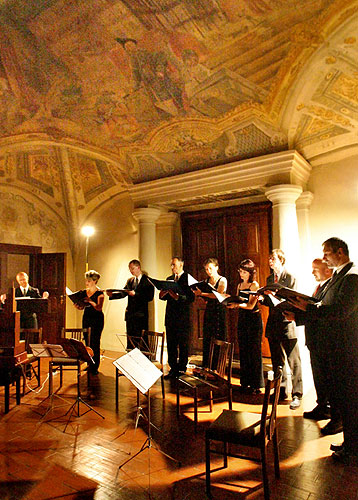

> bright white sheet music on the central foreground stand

[{"left": 113, "top": 348, "right": 163, "bottom": 394}]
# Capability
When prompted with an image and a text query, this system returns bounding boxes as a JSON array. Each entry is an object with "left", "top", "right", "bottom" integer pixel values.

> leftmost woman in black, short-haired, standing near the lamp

[{"left": 76, "top": 270, "right": 104, "bottom": 375}]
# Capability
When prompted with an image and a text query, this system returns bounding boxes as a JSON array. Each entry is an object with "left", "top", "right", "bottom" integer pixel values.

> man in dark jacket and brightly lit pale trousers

[{"left": 263, "top": 249, "right": 303, "bottom": 410}]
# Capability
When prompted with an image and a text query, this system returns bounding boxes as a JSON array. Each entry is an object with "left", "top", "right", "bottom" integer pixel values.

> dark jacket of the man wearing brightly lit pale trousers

[{"left": 263, "top": 269, "right": 296, "bottom": 339}]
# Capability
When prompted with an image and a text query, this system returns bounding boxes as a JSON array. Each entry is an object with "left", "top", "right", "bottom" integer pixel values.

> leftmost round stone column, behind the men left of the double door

[{"left": 133, "top": 207, "right": 161, "bottom": 330}]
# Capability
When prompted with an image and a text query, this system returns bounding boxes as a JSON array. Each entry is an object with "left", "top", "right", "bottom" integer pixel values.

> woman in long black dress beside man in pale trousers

[{"left": 227, "top": 259, "right": 264, "bottom": 394}]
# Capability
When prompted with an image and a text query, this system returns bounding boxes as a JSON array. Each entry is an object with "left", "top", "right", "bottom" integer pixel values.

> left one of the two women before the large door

[{"left": 193, "top": 257, "right": 227, "bottom": 367}]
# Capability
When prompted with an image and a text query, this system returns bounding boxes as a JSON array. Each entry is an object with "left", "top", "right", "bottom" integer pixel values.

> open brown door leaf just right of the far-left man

[{"left": 30, "top": 253, "right": 66, "bottom": 343}]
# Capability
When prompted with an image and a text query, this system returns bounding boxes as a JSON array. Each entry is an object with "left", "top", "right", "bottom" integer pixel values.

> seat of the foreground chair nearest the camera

[{"left": 206, "top": 410, "right": 261, "bottom": 446}]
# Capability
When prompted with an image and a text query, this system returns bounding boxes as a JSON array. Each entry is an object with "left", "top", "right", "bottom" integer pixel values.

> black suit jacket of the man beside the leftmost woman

[{"left": 109, "top": 274, "right": 154, "bottom": 321}]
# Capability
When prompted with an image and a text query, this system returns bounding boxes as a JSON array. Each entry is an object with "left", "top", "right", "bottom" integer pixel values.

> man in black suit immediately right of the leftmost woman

[{"left": 107, "top": 259, "right": 154, "bottom": 347}]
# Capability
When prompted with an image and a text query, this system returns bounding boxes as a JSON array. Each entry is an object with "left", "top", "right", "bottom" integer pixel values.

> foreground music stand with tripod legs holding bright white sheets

[{"left": 113, "top": 348, "right": 180, "bottom": 497}]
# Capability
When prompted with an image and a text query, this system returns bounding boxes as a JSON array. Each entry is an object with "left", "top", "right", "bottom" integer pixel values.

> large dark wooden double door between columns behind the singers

[{"left": 181, "top": 203, "right": 272, "bottom": 357}]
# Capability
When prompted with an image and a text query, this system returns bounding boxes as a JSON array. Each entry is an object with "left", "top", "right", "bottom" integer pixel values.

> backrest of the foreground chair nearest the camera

[{"left": 260, "top": 366, "right": 282, "bottom": 442}]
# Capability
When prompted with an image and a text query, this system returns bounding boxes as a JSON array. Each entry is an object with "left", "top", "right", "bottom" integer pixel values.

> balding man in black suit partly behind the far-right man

[{"left": 285, "top": 259, "right": 334, "bottom": 424}]
